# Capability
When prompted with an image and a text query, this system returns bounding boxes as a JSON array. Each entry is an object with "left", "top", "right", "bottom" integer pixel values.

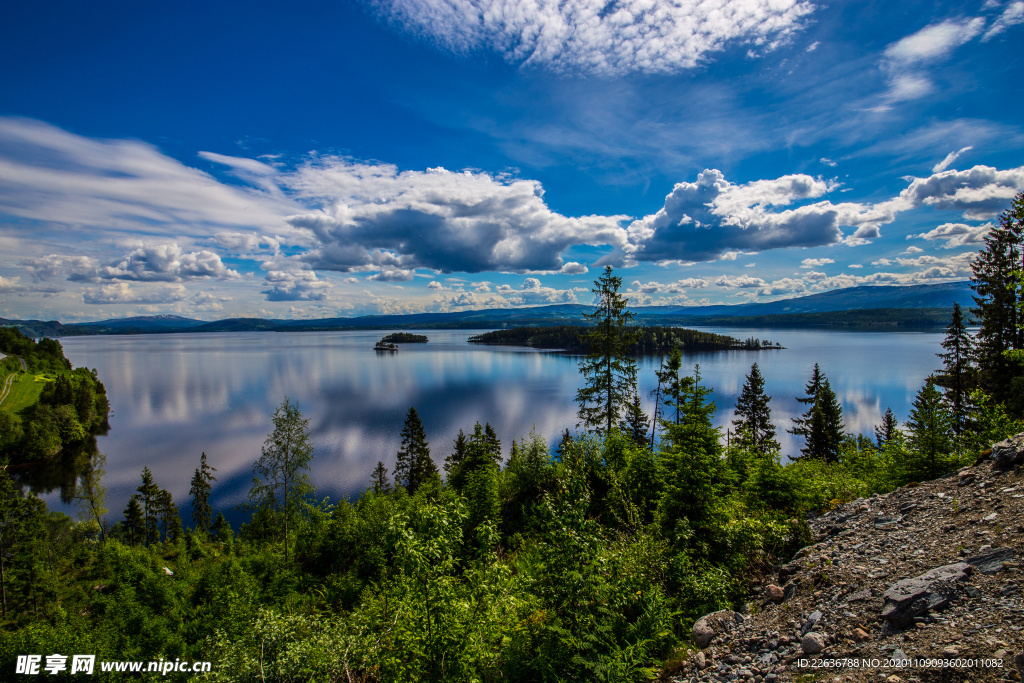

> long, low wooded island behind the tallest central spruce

[{"left": 469, "top": 325, "right": 782, "bottom": 355}]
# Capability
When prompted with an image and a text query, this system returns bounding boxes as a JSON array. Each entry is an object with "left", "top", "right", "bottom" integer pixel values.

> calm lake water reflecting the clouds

[{"left": 59, "top": 328, "right": 943, "bottom": 521}]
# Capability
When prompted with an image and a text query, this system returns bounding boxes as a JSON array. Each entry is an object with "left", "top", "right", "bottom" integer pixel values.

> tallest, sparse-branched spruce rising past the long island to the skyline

[{"left": 577, "top": 266, "right": 637, "bottom": 433}]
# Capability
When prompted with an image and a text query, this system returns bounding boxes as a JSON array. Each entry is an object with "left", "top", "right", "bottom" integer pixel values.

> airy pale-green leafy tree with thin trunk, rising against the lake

[{"left": 249, "top": 396, "right": 313, "bottom": 563}]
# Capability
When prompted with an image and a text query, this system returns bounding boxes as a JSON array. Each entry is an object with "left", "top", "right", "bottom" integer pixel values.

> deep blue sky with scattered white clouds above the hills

[{"left": 0, "top": 0, "right": 1024, "bottom": 322}]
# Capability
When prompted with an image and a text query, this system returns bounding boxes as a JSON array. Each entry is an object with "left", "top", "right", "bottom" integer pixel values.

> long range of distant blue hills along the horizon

[{"left": 0, "top": 282, "right": 974, "bottom": 337}]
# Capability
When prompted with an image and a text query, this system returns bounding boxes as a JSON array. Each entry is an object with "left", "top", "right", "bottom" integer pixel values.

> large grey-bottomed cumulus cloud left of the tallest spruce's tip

[{"left": 287, "top": 158, "right": 626, "bottom": 272}]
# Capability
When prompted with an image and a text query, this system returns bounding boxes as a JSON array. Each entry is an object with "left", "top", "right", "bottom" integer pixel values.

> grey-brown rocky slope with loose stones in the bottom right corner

[{"left": 670, "top": 434, "right": 1024, "bottom": 683}]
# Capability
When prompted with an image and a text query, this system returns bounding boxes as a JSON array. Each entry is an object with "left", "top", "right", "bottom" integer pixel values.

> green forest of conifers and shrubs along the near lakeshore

[{"left": 0, "top": 195, "right": 1024, "bottom": 682}]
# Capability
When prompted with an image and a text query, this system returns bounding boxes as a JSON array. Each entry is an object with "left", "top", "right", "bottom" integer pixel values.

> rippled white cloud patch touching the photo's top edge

[{"left": 371, "top": 0, "right": 814, "bottom": 75}]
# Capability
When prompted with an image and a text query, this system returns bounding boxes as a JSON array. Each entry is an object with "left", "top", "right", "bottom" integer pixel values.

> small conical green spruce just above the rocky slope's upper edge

[{"left": 906, "top": 377, "right": 952, "bottom": 481}]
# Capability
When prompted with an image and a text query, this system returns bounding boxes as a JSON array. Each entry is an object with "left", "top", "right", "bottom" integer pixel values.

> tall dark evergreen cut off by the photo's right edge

[{"left": 971, "top": 193, "right": 1024, "bottom": 409}]
